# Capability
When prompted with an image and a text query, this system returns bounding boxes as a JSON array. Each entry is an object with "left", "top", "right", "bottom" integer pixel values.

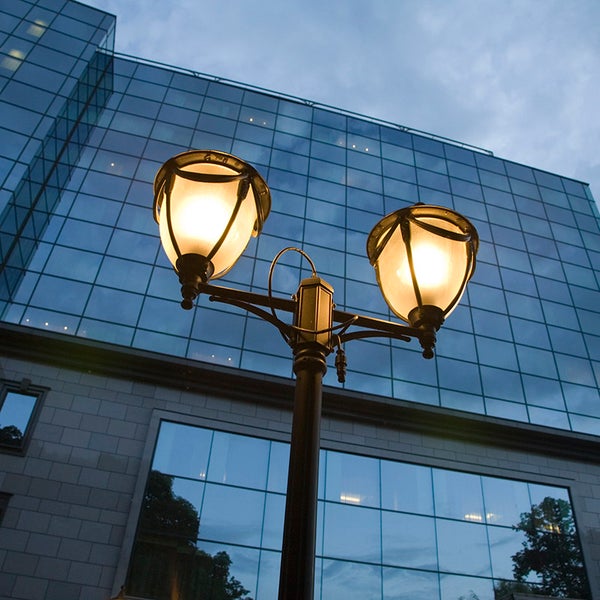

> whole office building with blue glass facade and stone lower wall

[{"left": 0, "top": 0, "right": 600, "bottom": 600}]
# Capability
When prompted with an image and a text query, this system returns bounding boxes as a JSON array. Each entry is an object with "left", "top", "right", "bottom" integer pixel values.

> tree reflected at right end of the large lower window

[{"left": 512, "top": 497, "right": 590, "bottom": 599}]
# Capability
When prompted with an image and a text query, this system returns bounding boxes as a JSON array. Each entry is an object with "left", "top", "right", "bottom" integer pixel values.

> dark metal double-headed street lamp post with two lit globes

[{"left": 154, "top": 150, "right": 479, "bottom": 600}]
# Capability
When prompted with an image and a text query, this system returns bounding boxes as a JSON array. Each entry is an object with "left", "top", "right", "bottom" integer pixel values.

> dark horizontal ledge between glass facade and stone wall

[{"left": 0, "top": 323, "right": 600, "bottom": 464}]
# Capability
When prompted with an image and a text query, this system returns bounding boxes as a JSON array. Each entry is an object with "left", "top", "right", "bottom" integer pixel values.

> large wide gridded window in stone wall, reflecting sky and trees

[{"left": 126, "top": 421, "right": 590, "bottom": 600}]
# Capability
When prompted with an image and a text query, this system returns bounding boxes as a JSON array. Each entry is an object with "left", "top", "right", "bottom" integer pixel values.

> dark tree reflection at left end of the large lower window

[{"left": 126, "top": 471, "right": 252, "bottom": 600}]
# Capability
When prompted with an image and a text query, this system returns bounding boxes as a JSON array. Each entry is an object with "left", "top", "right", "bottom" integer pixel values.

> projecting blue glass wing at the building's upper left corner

[{"left": 0, "top": 3, "right": 114, "bottom": 306}]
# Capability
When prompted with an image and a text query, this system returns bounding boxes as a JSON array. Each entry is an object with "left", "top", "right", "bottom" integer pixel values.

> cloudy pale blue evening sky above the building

[{"left": 84, "top": 0, "right": 600, "bottom": 201}]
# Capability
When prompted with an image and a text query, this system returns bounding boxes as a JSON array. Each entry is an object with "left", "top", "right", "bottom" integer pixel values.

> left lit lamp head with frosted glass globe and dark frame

[{"left": 154, "top": 150, "right": 271, "bottom": 308}]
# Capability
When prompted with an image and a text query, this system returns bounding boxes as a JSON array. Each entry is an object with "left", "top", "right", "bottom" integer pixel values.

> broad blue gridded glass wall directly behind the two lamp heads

[{"left": 2, "top": 37, "right": 600, "bottom": 433}]
